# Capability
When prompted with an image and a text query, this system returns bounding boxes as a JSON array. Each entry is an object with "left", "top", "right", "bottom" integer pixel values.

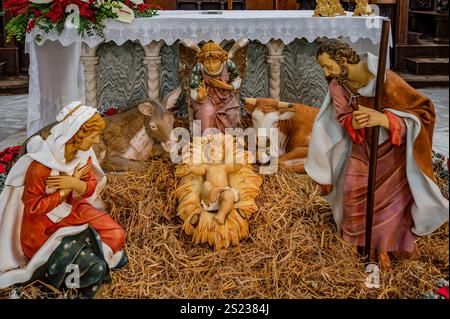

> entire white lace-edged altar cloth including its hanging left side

[{"left": 26, "top": 10, "right": 392, "bottom": 135}]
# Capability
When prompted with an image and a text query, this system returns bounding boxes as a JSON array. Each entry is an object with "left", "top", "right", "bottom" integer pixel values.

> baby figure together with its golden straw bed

[{"left": 176, "top": 134, "right": 262, "bottom": 250}]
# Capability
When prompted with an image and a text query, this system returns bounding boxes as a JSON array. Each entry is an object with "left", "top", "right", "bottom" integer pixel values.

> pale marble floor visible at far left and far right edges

[{"left": 0, "top": 88, "right": 449, "bottom": 156}]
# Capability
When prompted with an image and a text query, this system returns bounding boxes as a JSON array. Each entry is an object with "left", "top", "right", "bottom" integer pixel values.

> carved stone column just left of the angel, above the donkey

[{"left": 144, "top": 40, "right": 164, "bottom": 100}]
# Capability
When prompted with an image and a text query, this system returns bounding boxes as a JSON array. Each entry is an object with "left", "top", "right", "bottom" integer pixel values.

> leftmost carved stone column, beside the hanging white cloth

[{"left": 80, "top": 43, "right": 98, "bottom": 107}]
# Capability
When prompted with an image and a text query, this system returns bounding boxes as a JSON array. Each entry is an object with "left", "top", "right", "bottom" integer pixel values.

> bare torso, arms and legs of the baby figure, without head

[{"left": 190, "top": 163, "right": 242, "bottom": 225}]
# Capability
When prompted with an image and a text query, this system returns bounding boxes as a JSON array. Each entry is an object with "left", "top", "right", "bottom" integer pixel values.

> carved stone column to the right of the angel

[{"left": 266, "top": 39, "right": 285, "bottom": 100}]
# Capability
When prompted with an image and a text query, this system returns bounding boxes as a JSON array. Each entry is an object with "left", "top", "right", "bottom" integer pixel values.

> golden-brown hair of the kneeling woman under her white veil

[{"left": 64, "top": 113, "right": 106, "bottom": 163}]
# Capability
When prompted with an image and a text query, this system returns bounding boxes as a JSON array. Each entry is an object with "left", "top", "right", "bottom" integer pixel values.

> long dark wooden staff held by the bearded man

[{"left": 364, "top": 19, "right": 391, "bottom": 263}]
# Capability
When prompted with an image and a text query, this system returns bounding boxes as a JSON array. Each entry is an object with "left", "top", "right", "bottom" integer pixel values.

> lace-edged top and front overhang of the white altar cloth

[{"left": 27, "top": 10, "right": 390, "bottom": 47}]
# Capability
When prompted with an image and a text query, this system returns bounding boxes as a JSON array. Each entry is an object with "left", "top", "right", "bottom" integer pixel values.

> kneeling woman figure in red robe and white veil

[{"left": 0, "top": 102, "right": 126, "bottom": 298}]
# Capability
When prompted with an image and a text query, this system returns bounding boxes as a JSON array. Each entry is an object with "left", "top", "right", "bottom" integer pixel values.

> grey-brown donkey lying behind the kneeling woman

[{"left": 22, "top": 88, "right": 181, "bottom": 172}]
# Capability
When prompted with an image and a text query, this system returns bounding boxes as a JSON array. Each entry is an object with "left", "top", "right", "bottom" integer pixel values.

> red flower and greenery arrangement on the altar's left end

[{"left": 3, "top": 0, "right": 160, "bottom": 41}]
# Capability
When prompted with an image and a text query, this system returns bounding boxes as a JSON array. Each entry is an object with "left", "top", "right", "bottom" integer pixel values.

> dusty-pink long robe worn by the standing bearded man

[{"left": 330, "top": 81, "right": 415, "bottom": 252}]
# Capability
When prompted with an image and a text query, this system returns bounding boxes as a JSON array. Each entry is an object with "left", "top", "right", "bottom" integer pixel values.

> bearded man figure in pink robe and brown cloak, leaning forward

[{"left": 305, "top": 39, "right": 449, "bottom": 269}]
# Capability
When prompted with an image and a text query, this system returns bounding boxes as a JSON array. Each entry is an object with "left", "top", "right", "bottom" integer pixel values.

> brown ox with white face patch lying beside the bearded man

[{"left": 243, "top": 98, "right": 319, "bottom": 173}]
